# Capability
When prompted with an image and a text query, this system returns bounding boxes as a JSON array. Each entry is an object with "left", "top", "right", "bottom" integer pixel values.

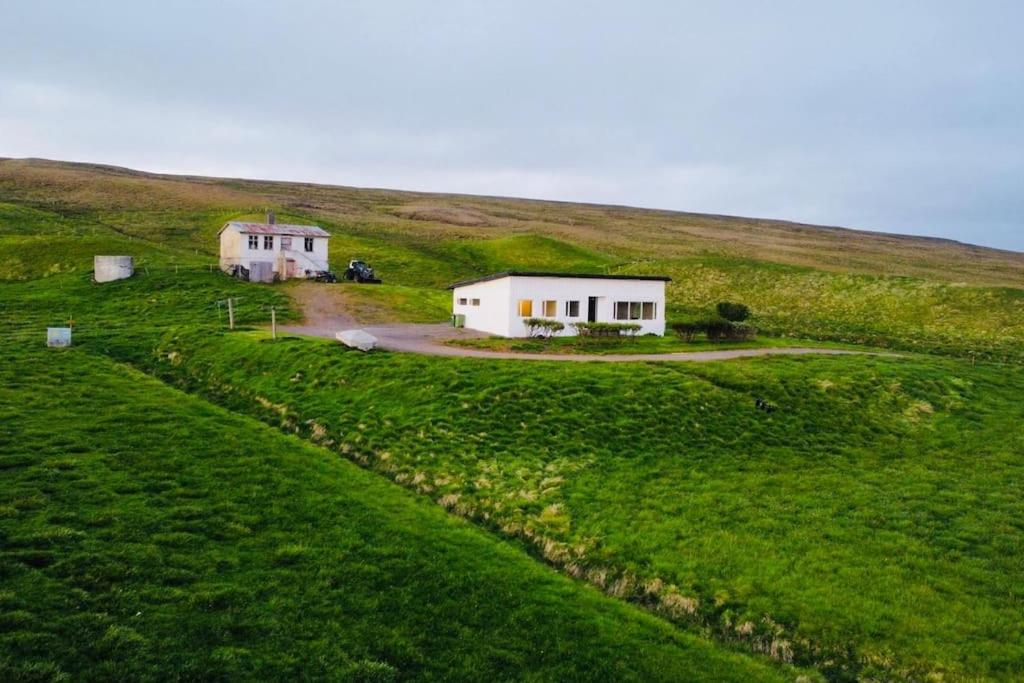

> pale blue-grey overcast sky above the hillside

[{"left": 0, "top": 0, "right": 1024, "bottom": 250}]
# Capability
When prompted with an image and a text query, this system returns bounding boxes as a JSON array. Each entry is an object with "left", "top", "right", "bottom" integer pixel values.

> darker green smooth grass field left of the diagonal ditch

[{"left": 0, "top": 343, "right": 782, "bottom": 681}]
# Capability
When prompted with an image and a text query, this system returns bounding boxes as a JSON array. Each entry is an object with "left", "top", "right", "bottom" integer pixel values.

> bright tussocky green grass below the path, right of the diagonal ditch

[{"left": 144, "top": 335, "right": 1024, "bottom": 677}]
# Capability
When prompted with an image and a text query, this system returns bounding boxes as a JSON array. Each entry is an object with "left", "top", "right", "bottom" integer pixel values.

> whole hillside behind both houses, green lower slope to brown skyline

[{"left": 0, "top": 160, "right": 1024, "bottom": 359}]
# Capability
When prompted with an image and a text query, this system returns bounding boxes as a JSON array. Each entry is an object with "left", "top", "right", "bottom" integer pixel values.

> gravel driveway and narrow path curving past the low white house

[{"left": 279, "top": 283, "right": 888, "bottom": 362}]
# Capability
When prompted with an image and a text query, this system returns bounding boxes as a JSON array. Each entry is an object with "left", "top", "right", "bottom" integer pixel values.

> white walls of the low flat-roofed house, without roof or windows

[{"left": 452, "top": 276, "right": 665, "bottom": 337}]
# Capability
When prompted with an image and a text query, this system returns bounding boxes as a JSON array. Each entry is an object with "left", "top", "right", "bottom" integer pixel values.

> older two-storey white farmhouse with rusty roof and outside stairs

[{"left": 220, "top": 213, "right": 331, "bottom": 283}]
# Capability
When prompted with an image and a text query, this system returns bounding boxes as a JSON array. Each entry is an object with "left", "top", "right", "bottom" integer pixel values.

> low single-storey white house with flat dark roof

[{"left": 449, "top": 272, "right": 670, "bottom": 337}]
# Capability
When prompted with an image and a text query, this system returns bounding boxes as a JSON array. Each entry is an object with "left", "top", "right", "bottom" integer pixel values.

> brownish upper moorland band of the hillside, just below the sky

[{"left": 0, "top": 160, "right": 1024, "bottom": 287}]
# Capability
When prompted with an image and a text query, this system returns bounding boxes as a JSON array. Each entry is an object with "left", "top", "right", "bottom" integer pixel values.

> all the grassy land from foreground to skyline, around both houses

[{"left": 0, "top": 161, "right": 1024, "bottom": 681}]
